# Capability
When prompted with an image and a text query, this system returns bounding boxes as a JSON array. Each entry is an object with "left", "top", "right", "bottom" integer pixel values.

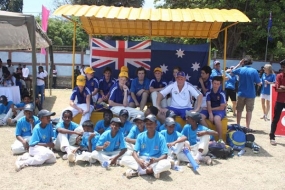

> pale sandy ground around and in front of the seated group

[{"left": 0, "top": 90, "right": 285, "bottom": 190}]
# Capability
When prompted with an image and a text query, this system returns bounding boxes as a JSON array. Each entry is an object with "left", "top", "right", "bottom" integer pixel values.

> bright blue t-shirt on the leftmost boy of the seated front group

[{"left": 15, "top": 116, "right": 40, "bottom": 137}]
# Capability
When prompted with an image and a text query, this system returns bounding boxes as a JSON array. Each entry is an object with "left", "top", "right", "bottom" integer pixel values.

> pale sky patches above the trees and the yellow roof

[{"left": 23, "top": 0, "right": 158, "bottom": 16}]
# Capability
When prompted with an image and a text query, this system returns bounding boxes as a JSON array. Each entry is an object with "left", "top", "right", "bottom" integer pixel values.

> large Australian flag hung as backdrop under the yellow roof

[{"left": 90, "top": 38, "right": 209, "bottom": 85}]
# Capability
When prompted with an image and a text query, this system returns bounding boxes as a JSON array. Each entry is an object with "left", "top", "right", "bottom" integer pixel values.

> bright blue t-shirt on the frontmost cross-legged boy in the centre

[{"left": 134, "top": 131, "right": 168, "bottom": 158}]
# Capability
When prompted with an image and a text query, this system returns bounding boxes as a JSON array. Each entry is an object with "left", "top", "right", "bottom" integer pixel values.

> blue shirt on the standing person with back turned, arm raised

[{"left": 232, "top": 65, "right": 260, "bottom": 98}]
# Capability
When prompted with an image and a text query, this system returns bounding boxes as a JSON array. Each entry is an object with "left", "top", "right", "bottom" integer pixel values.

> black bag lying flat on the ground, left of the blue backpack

[{"left": 209, "top": 142, "right": 234, "bottom": 159}]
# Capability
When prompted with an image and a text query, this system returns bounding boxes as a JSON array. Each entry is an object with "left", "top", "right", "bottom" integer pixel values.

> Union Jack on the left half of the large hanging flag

[{"left": 91, "top": 38, "right": 151, "bottom": 71}]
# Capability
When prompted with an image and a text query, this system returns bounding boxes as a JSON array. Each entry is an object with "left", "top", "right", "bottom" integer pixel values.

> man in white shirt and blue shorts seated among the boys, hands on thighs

[{"left": 157, "top": 71, "right": 203, "bottom": 119}]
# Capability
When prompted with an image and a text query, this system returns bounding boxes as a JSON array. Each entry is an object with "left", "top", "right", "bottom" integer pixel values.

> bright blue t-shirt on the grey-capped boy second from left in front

[{"left": 29, "top": 123, "right": 54, "bottom": 146}]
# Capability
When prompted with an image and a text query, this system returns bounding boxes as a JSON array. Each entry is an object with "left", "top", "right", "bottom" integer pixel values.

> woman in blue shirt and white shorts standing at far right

[{"left": 260, "top": 64, "right": 276, "bottom": 121}]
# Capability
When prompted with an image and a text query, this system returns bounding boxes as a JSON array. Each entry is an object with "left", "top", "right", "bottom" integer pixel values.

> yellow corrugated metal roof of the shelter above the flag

[{"left": 54, "top": 5, "right": 250, "bottom": 39}]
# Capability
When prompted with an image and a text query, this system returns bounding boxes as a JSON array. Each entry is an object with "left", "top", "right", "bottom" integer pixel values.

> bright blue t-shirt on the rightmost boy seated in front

[{"left": 181, "top": 124, "right": 212, "bottom": 146}]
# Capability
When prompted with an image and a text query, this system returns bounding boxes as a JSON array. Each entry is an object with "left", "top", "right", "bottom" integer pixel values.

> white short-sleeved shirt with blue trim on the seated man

[{"left": 160, "top": 82, "right": 201, "bottom": 109}]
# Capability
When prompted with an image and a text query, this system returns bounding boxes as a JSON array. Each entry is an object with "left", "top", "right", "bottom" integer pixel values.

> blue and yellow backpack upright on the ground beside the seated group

[{"left": 227, "top": 124, "right": 246, "bottom": 151}]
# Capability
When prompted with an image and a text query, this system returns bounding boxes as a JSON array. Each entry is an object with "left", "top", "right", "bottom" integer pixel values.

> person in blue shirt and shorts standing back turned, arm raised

[{"left": 231, "top": 56, "right": 261, "bottom": 129}]
